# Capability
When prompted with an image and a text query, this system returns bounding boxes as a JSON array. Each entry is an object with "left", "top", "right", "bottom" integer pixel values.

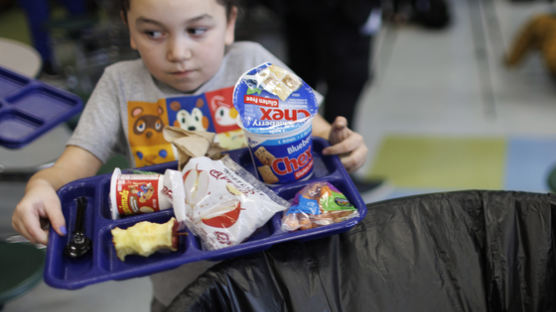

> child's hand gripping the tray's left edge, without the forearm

[{"left": 12, "top": 180, "right": 66, "bottom": 245}]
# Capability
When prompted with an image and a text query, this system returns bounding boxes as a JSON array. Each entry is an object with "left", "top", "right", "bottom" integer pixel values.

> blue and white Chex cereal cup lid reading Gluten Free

[{"left": 233, "top": 63, "right": 318, "bottom": 135}]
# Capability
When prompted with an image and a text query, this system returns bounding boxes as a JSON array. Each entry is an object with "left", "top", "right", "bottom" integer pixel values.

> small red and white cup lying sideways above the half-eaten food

[{"left": 109, "top": 168, "right": 172, "bottom": 220}]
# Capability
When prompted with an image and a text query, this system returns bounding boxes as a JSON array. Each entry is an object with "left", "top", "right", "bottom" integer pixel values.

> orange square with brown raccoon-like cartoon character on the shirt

[{"left": 127, "top": 99, "right": 175, "bottom": 167}]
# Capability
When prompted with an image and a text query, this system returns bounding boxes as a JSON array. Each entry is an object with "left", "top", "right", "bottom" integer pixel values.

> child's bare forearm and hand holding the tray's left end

[{"left": 12, "top": 146, "right": 102, "bottom": 244}]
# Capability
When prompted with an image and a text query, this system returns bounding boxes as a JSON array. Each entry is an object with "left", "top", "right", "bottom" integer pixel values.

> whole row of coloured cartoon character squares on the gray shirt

[{"left": 127, "top": 87, "right": 247, "bottom": 167}]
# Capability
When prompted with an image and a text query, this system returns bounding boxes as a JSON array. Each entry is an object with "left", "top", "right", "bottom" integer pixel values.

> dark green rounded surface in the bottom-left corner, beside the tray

[{"left": 0, "top": 241, "right": 45, "bottom": 306}]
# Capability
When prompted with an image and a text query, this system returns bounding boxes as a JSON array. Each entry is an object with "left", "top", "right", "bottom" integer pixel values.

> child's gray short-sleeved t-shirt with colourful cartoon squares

[{"left": 67, "top": 42, "right": 322, "bottom": 305}]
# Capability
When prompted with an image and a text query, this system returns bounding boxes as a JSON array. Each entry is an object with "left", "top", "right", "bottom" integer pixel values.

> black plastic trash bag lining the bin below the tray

[{"left": 168, "top": 191, "right": 556, "bottom": 312}]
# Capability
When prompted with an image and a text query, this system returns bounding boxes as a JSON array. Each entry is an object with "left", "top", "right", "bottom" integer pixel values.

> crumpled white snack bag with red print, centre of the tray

[{"left": 164, "top": 156, "right": 289, "bottom": 250}]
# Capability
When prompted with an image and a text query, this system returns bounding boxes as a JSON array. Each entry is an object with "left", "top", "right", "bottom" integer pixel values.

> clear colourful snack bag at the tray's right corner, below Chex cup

[{"left": 282, "top": 182, "right": 359, "bottom": 231}]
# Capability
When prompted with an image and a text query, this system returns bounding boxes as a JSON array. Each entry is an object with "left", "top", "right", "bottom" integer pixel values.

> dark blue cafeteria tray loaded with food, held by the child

[{"left": 44, "top": 138, "right": 367, "bottom": 289}]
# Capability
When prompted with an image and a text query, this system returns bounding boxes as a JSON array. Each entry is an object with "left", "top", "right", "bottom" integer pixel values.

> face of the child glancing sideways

[{"left": 127, "top": 0, "right": 237, "bottom": 92}]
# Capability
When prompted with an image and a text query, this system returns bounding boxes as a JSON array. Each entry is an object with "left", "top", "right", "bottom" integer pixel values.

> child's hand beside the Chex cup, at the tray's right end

[{"left": 322, "top": 117, "right": 368, "bottom": 172}]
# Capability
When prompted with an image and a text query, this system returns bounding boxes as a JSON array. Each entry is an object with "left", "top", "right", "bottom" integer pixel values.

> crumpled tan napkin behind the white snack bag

[{"left": 162, "top": 126, "right": 225, "bottom": 170}]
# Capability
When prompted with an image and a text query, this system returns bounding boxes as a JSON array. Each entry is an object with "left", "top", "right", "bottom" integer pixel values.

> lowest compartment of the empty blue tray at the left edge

[{"left": 0, "top": 110, "right": 44, "bottom": 145}]
